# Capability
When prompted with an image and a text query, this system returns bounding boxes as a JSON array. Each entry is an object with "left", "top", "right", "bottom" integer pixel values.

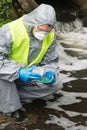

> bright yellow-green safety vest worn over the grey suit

[{"left": 8, "top": 17, "right": 54, "bottom": 66}]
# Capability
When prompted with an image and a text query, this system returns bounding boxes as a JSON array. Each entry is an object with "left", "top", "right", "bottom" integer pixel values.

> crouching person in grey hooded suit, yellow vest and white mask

[{"left": 0, "top": 4, "right": 62, "bottom": 122}]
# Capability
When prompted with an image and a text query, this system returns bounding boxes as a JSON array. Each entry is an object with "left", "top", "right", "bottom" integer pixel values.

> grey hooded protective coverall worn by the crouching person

[{"left": 0, "top": 4, "right": 62, "bottom": 113}]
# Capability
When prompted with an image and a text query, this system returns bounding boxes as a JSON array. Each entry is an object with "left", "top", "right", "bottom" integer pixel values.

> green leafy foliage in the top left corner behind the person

[{"left": 0, "top": 0, "right": 12, "bottom": 26}]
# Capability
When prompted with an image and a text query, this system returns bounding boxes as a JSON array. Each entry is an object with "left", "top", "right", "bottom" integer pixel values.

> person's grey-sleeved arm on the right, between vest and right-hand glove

[{"left": 40, "top": 34, "right": 59, "bottom": 82}]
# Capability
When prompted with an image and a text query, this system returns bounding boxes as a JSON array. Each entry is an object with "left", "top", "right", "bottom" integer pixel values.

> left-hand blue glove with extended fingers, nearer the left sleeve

[{"left": 18, "top": 66, "right": 41, "bottom": 82}]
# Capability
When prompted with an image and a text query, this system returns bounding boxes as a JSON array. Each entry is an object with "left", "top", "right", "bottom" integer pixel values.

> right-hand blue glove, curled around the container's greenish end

[{"left": 41, "top": 71, "right": 55, "bottom": 85}]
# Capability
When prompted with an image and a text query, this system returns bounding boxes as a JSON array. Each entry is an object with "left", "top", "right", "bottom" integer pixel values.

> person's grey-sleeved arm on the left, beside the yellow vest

[{"left": 0, "top": 25, "right": 22, "bottom": 82}]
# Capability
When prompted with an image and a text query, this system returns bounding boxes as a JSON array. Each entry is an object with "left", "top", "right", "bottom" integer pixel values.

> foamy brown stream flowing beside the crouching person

[{"left": 0, "top": 20, "right": 87, "bottom": 130}]
